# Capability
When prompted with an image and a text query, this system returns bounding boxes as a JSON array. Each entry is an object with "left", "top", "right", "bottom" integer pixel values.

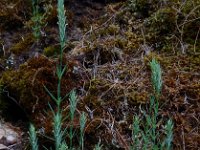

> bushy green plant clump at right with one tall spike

[{"left": 130, "top": 59, "right": 173, "bottom": 150}]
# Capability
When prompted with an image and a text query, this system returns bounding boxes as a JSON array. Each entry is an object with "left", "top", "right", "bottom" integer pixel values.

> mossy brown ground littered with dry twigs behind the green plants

[{"left": 0, "top": 0, "right": 200, "bottom": 150}]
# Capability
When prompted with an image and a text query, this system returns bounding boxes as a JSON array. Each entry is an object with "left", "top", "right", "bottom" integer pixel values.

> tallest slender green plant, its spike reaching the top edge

[{"left": 31, "top": 0, "right": 67, "bottom": 150}]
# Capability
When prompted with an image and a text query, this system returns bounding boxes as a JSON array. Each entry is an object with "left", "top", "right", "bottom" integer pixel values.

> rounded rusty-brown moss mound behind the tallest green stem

[{"left": 0, "top": 56, "right": 80, "bottom": 130}]
